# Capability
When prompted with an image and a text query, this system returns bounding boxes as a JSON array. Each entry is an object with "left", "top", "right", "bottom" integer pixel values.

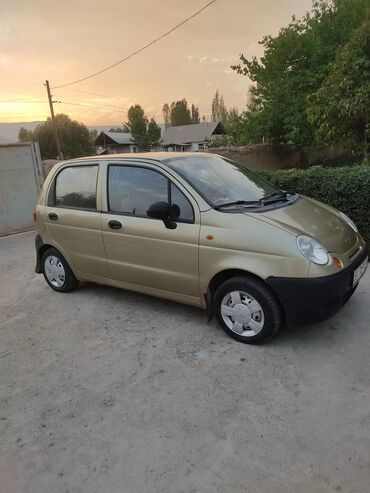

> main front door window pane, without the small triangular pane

[{"left": 108, "top": 165, "right": 168, "bottom": 216}]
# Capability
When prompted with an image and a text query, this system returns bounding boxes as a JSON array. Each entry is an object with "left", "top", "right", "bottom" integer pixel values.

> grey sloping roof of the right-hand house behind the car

[{"left": 162, "top": 122, "right": 225, "bottom": 146}]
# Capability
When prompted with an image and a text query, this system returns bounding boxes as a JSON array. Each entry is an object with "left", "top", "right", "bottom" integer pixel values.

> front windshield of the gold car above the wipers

[{"left": 164, "top": 154, "right": 280, "bottom": 206}]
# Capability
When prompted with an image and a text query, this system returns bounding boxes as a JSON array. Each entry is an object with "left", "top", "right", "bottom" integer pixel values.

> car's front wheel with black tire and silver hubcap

[{"left": 213, "top": 277, "right": 282, "bottom": 344}]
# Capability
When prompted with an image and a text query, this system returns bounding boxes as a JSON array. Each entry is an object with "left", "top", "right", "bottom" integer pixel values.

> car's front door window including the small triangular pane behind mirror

[{"left": 108, "top": 165, "right": 194, "bottom": 222}]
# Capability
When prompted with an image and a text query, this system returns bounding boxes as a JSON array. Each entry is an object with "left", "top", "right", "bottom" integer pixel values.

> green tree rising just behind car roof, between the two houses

[{"left": 126, "top": 104, "right": 161, "bottom": 151}]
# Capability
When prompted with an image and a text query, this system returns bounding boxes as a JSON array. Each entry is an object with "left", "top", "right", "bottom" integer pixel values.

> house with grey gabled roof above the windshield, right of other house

[{"left": 162, "top": 122, "right": 226, "bottom": 152}]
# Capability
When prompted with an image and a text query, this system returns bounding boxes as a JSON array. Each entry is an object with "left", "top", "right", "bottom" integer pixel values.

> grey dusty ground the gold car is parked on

[{"left": 0, "top": 233, "right": 370, "bottom": 493}]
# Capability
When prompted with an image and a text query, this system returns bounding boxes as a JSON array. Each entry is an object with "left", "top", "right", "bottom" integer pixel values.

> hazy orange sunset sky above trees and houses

[{"left": 0, "top": 0, "right": 311, "bottom": 125}]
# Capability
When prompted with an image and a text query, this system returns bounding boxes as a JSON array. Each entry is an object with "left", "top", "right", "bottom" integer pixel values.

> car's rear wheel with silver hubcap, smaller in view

[{"left": 41, "top": 248, "right": 78, "bottom": 293}]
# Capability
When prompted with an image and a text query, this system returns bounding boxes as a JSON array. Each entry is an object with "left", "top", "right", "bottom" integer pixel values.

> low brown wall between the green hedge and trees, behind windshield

[{"left": 207, "top": 144, "right": 358, "bottom": 170}]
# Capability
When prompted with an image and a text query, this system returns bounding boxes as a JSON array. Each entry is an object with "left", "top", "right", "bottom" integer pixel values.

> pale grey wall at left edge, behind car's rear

[{"left": 0, "top": 142, "right": 43, "bottom": 235}]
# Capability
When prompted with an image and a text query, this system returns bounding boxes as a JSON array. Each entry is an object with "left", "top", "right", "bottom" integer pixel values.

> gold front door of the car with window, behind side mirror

[{"left": 102, "top": 164, "right": 200, "bottom": 298}]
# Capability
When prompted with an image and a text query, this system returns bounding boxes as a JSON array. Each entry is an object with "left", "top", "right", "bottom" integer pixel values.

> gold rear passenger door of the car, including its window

[{"left": 44, "top": 162, "right": 108, "bottom": 277}]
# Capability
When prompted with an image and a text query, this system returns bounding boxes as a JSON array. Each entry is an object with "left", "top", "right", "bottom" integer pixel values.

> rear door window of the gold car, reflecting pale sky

[{"left": 55, "top": 166, "right": 98, "bottom": 209}]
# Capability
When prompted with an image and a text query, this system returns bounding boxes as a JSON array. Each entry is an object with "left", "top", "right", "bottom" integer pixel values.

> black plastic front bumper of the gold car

[{"left": 266, "top": 252, "right": 367, "bottom": 326}]
